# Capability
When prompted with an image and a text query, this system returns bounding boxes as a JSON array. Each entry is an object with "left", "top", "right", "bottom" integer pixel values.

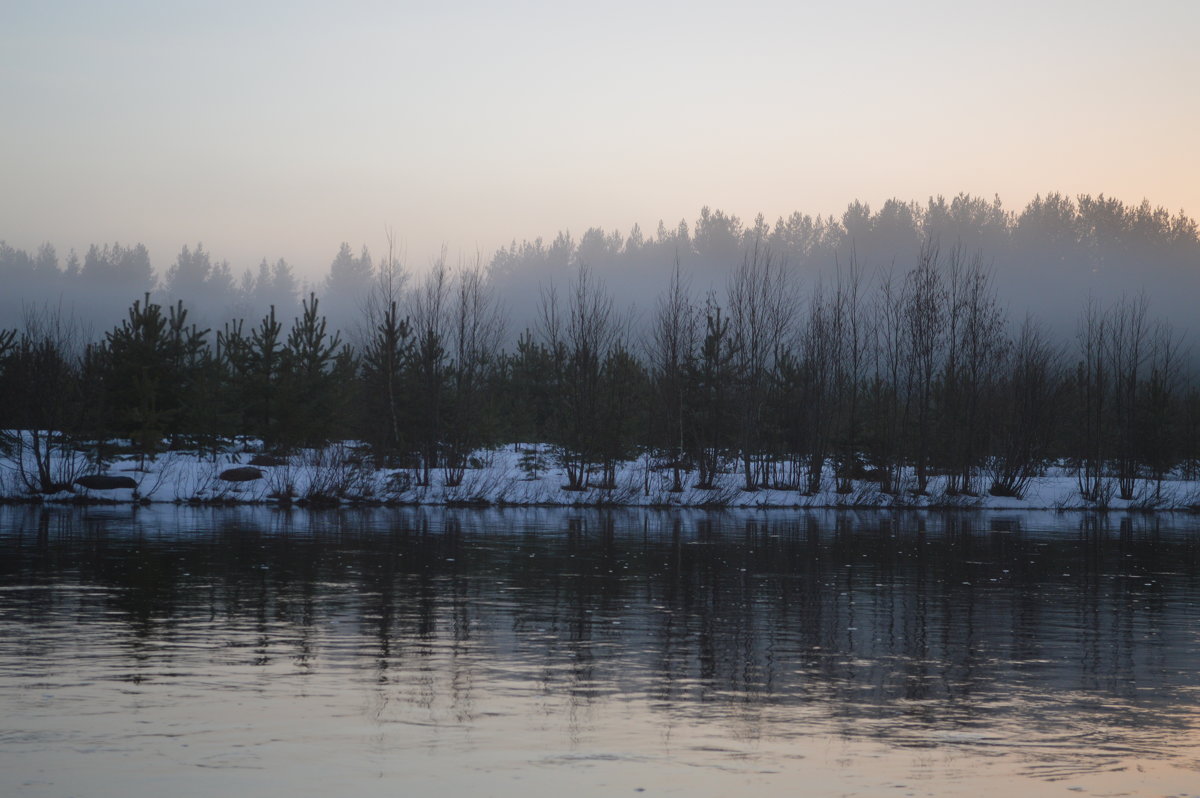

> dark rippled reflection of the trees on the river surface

[{"left": 0, "top": 508, "right": 1200, "bottom": 740}]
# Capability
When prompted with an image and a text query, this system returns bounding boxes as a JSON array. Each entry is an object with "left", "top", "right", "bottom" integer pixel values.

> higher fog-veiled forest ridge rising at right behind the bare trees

[{"left": 492, "top": 193, "right": 1200, "bottom": 337}]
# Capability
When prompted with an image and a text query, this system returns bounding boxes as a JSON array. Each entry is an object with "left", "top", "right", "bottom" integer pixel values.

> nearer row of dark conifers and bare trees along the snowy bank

[{"left": 0, "top": 238, "right": 1200, "bottom": 502}]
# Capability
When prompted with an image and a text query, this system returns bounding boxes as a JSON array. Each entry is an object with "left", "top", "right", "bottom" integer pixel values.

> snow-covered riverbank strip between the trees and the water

[{"left": 0, "top": 442, "right": 1200, "bottom": 511}]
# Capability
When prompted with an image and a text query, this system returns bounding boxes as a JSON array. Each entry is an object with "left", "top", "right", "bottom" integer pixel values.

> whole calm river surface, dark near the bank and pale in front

[{"left": 0, "top": 508, "right": 1200, "bottom": 796}]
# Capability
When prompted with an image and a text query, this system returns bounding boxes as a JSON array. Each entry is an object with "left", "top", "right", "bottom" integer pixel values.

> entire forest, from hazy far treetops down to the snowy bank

[{"left": 0, "top": 196, "right": 1200, "bottom": 503}]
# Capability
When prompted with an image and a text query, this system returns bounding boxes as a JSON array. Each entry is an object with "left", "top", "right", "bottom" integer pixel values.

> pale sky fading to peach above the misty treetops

[{"left": 0, "top": 0, "right": 1200, "bottom": 277}]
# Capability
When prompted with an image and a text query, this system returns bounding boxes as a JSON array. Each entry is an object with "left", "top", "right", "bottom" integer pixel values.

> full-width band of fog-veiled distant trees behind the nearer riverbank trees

[{"left": 0, "top": 193, "right": 1200, "bottom": 352}]
